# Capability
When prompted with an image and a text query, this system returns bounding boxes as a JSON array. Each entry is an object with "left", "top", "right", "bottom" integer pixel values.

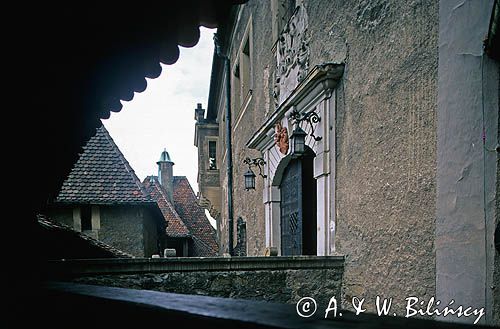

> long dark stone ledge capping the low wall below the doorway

[{"left": 46, "top": 256, "right": 344, "bottom": 277}]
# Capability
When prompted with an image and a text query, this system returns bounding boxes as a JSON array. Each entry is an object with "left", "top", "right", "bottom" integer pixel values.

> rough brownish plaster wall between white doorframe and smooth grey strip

[{"left": 306, "top": 0, "right": 438, "bottom": 312}]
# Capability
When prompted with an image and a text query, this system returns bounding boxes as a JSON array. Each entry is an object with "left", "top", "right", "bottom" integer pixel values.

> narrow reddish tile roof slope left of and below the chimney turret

[{"left": 143, "top": 176, "right": 190, "bottom": 238}]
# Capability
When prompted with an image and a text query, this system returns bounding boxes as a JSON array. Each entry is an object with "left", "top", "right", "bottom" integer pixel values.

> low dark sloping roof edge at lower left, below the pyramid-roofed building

[{"left": 37, "top": 214, "right": 134, "bottom": 258}]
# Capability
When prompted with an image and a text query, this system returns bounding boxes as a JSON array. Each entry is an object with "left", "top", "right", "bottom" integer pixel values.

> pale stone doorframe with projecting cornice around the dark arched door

[{"left": 247, "top": 63, "right": 344, "bottom": 256}]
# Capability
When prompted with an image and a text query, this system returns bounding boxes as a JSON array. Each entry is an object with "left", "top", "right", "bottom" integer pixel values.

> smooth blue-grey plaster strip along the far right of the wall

[{"left": 436, "top": 0, "right": 498, "bottom": 323}]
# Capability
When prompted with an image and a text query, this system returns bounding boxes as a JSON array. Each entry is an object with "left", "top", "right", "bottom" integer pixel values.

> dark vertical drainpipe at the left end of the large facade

[{"left": 214, "top": 33, "right": 234, "bottom": 256}]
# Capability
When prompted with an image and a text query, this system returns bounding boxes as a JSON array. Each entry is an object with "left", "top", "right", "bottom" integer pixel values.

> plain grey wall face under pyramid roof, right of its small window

[{"left": 99, "top": 206, "right": 144, "bottom": 257}]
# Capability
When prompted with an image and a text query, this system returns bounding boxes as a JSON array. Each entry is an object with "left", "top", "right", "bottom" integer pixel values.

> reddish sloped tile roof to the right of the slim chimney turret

[{"left": 174, "top": 176, "right": 219, "bottom": 257}]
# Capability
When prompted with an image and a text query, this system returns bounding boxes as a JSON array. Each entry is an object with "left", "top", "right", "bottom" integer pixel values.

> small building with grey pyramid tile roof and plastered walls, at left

[{"left": 49, "top": 126, "right": 167, "bottom": 257}]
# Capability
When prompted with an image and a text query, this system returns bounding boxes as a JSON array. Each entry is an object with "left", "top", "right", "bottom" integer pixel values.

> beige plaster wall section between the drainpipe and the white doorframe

[{"left": 221, "top": 1, "right": 274, "bottom": 256}]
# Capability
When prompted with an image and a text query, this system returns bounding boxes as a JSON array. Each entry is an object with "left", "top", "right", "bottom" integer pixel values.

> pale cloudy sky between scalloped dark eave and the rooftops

[{"left": 102, "top": 27, "right": 216, "bottom": 224}]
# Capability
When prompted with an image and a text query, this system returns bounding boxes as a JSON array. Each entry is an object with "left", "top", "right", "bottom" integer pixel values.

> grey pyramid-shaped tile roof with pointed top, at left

[{"left": 56, "top": 126, "right": 153, "bottom": 204}]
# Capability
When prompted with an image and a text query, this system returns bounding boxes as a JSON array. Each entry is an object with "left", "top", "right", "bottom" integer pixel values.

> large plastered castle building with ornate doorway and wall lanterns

[{"left": 195, "top": 0, "right": 500, "bottom": 323}]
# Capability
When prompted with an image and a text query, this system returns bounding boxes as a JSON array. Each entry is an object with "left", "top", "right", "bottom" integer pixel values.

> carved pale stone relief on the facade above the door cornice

[{"left": 273, "top": 6, "right": 310, "bottom": 108}]
